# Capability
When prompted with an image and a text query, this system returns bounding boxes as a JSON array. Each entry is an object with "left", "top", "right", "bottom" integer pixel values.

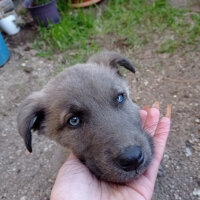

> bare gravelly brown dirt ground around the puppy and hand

[{"left": 0, "top": 21, "right": 200, "bottom": 200}]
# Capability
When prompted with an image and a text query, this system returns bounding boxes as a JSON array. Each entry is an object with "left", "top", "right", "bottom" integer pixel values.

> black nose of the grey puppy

[{"left": 116, "top": 146, "right": 144, "bottom": 171}]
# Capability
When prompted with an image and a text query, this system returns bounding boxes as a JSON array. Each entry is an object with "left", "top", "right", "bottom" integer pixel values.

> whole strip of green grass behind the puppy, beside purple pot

[{"left": 35, "top": 0, "right": 200, "bottom": 61}]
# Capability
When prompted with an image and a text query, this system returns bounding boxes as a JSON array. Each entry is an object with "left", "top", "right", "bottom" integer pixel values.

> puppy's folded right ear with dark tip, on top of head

[{"left": 88, "top": 51, "right": 135, "bottom": 74}]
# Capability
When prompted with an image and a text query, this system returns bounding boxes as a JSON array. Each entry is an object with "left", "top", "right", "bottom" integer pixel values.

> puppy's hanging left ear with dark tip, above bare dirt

[{"left": 17, "top": 92, "right": 45, "bottom": 152}]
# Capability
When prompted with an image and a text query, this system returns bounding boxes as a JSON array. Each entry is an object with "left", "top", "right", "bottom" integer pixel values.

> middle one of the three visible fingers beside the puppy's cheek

[{"left": 144, "top": 103, "right": 160, "bottom": 136}]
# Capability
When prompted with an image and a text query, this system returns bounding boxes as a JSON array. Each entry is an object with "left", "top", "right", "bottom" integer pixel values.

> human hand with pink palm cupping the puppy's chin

[{"left": 51, "top": 102, "right": 171, "bottom": 200}]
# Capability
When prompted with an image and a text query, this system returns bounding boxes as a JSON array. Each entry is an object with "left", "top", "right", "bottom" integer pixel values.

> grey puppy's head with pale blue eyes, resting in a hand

[{"left": 17, "top": 51, "right": 153, "bottom": 183}]
